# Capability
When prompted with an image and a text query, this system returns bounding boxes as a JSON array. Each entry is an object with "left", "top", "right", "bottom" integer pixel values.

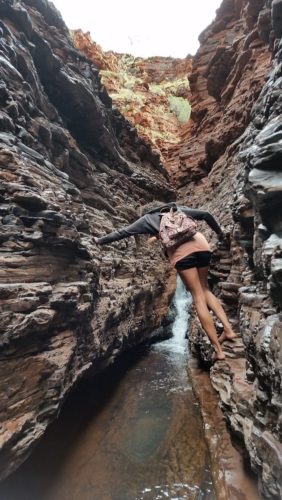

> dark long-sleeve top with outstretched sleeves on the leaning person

[{"left": 97, "top": 203, "right": 222, "bottom": 245}]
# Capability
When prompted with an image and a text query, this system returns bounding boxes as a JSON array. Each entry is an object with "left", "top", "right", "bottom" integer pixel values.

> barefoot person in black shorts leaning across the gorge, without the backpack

[{"left": 95, "top": 202, "right": 236, "bottom": 361}]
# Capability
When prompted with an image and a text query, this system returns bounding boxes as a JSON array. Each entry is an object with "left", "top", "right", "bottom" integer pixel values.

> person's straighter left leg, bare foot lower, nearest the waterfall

[{"left": 178, "top": 267, "right": 225, "bottom": 359}]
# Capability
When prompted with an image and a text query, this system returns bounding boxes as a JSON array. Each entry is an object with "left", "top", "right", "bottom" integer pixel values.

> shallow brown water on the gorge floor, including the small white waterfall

[{"left": 0, "top": 282, "right": 214, "bottom": 500}]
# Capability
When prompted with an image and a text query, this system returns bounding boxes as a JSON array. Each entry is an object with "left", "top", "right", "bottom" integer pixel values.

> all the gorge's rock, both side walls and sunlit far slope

[{"left": 0, "top": 0, "right": 282, "bottom": 500}]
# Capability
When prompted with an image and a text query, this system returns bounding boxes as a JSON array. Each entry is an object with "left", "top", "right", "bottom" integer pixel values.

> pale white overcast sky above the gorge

[{"left": 52, "top": 0, "right": 222, "bottom": 58}]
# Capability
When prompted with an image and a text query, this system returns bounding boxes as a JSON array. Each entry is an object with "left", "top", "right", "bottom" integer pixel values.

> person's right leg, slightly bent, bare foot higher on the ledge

[{"left": 198, "top": 267, "right": 237, "bottom": 342}]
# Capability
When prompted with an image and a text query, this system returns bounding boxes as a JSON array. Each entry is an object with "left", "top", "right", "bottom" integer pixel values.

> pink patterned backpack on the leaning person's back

[{"left": 159, "top": 208, "right": 197, "bottom": 250}]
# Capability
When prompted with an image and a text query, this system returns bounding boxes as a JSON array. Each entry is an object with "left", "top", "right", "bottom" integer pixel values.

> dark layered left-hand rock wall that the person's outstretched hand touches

[{"left": 0, "top": 0, "right": 174, "bottom": 477}]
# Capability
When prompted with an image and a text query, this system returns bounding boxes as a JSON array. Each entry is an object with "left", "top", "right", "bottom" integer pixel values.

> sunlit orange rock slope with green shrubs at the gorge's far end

[{"left": 72, "top": 30, "right": 192, "bottom": 170}]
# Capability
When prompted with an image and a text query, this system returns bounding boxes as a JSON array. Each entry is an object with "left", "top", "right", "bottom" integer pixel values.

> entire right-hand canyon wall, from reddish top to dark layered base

[{"left": 170, "top": 0, "right": 282, "bottom": 500}]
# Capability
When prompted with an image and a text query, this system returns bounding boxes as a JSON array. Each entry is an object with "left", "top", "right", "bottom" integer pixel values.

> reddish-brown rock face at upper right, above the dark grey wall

[{"left": 168, "top": 0, "right": 271, "bottom": 187}]
